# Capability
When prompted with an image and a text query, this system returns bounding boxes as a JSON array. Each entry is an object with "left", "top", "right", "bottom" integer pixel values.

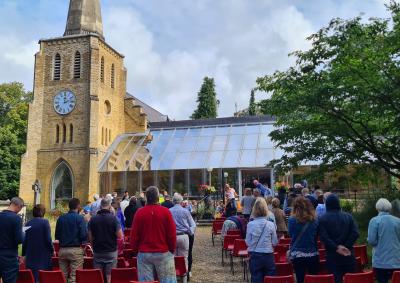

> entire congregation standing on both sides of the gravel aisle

[{"left": 0, "top": 180, "right": 400, "bottom": 283}]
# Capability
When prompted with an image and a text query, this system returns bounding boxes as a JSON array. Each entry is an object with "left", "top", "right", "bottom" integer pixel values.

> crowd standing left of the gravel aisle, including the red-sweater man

[{"left": 0, "top": 186, "right": 196, "bottom": 283}]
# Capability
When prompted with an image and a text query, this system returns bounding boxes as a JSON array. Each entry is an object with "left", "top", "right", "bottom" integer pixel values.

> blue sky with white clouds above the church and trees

[{"left": 0, "top": 0, "right": 389, "bottom": 120}]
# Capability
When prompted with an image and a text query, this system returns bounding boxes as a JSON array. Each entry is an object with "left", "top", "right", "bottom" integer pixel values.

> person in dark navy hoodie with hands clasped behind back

[{"left": 319, "top": 194, "right": 359, "bottom": 283}]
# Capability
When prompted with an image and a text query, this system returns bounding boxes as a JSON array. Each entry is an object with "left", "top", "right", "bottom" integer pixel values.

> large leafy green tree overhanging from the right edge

[{"left": 257, "top": 2, "right": 400, "bottom": 177}]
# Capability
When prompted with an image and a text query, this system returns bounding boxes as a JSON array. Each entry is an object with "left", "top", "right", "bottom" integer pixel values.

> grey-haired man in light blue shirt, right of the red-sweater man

[{"left": 169, "top": 194, "right": 196, "bottom": 280}]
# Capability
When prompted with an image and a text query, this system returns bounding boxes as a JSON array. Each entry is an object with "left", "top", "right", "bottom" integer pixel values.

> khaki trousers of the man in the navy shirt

[{"left": 58, "top": 247, "right": 83, "bottom": 283}]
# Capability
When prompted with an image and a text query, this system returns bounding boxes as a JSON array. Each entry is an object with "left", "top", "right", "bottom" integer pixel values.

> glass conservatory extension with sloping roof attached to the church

[{"left": 99, "top": 122, "right": 280, "bottom": 196}]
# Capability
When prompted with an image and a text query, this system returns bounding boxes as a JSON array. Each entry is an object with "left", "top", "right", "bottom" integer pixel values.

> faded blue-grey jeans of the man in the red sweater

[{"left": 137, "top": 252, "right": 177, "bottom": 283}]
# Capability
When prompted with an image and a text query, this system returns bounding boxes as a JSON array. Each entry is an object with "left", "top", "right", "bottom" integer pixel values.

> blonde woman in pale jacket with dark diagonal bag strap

[{"left": 246, "top": 198, "right": 278, "bottom": 283}]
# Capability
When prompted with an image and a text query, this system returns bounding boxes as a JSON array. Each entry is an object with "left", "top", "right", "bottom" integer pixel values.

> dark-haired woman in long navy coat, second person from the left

[{"left": 22, "top": 204, "right": 54, "bottom": 282}]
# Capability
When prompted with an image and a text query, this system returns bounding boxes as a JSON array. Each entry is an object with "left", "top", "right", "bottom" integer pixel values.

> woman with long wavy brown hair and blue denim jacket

[{"left": 288, "top": 197, "right": 319, "bottom": 283}]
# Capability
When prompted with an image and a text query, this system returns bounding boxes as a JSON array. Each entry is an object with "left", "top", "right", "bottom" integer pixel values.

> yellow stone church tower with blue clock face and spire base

[{"left": 20, "top": 0, "right": 147, "bottom": 208}]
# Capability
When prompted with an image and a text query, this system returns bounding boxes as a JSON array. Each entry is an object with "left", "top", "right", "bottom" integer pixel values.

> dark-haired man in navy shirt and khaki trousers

[{"left": 55, "top": 198, "right": 87, "bottom": 283}]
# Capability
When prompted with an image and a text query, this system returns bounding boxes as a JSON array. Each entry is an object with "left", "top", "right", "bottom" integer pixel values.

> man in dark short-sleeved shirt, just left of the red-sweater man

[{"left": 88, "top": 199, "right": 123, "bottom": 283}]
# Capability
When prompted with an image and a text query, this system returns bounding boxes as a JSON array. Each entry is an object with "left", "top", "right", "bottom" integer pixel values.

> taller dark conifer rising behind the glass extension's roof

[{"left": 190, "top": 77, "right": 219, "bottom": 120}]
